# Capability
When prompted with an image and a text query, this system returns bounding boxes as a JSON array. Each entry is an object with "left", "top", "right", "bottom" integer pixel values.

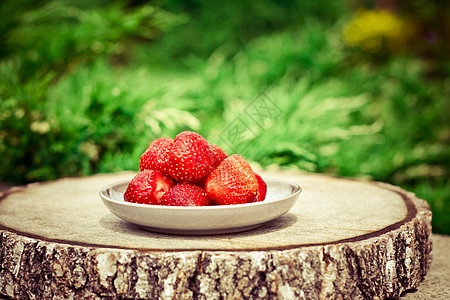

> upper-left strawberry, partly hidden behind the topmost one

[{"left": 139, "top": 138, "right": 173, "bottom": 176}]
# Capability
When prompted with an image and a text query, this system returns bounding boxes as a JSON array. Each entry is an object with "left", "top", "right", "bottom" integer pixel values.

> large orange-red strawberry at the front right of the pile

[{"left": 205, "top": 154, "right": 258, "bottom": 205}]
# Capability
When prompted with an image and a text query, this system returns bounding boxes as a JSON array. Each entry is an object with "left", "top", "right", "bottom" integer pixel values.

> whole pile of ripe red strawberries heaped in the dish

[{"left": 124, "top": 131, "right": 267, "bottom": 206}]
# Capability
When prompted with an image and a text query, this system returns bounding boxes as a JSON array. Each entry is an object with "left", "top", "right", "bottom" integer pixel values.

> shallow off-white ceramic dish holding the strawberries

[{"left": 100, "top": 179, "right": 301, "bottom": 234}]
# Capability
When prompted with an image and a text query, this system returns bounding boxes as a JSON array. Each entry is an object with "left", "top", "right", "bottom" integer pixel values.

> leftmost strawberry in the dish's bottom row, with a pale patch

[{"left": 123, "top": 170, "right": 175, "bottom": 205}]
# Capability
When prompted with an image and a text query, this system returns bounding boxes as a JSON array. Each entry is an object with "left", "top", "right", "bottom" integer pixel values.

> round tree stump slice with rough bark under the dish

[{"left": 0, "top": 172, "right": 431, "bottom": 299}]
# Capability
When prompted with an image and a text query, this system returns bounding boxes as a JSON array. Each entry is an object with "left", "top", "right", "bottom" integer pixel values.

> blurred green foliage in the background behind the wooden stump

[{"left": 0, "top": 0, "right": 450, "bottom": 234}]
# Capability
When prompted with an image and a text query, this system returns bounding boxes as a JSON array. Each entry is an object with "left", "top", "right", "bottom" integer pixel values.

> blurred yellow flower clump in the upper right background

[{"left": 342, "top": 9, "right": 414, "bottom": 53}]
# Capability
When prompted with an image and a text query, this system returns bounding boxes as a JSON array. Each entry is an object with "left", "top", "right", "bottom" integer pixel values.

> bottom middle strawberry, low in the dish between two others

[{"left": 161, "top": 183, "right": 212, "bottom": 206}]
